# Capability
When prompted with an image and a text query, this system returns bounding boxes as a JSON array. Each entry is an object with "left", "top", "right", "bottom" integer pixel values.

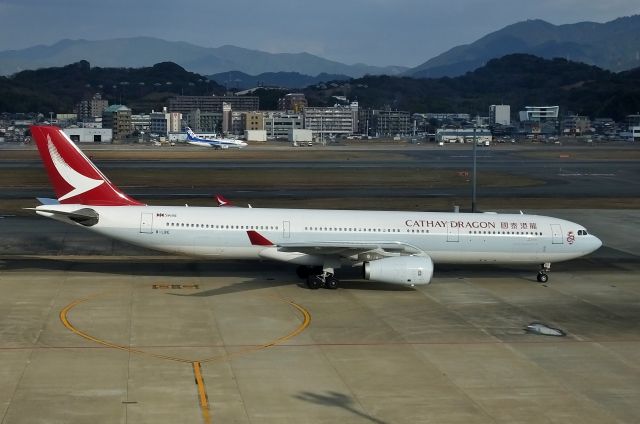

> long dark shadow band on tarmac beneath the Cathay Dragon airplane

[{"left": 0, "top": 246, "right": 640, "bottom": 297}]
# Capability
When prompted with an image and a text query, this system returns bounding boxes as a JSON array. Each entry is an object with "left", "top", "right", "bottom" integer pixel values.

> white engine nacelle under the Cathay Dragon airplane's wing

[{"left": 363, "top": 256, "right": 433, "bottom": 286}]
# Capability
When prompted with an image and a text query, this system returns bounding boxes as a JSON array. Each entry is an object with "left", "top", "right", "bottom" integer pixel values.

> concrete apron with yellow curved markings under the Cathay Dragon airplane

[{"left": 0, "top": 210, "right": 640, "bottom": 424}]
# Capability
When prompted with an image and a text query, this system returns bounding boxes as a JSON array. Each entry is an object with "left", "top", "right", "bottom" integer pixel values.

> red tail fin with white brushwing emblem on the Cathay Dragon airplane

[{"left": 31, "top": 125, "right": 142, "bottom": 206}]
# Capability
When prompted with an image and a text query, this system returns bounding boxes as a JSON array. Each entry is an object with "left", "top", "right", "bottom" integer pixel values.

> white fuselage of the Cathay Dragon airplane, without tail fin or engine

[{"left": 38, "top": 204, "right": 600, "bottom": 265}]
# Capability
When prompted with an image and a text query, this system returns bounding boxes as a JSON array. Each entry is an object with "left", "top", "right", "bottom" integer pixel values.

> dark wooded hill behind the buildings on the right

[{"left": 305, "top": 54, "right": 640, "bottom": 120}]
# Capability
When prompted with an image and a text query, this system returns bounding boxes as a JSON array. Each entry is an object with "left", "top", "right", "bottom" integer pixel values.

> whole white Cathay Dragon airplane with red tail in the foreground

[{"left": 31, "top": 126, "right": 602, "bottom": 289}]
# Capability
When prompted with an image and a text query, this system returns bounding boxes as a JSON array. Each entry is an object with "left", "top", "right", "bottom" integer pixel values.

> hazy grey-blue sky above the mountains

[{"left": 0, "top": 0, "right": 640, "bottom": 66}]
